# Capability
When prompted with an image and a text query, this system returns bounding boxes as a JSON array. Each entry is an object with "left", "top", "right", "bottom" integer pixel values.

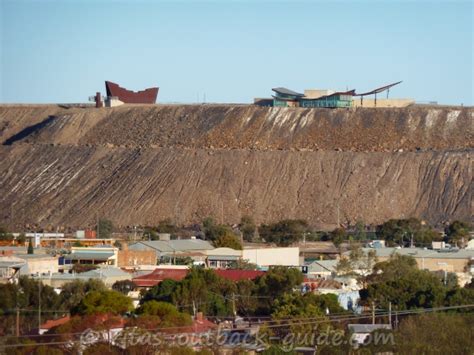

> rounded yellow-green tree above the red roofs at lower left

[{"left": 72, "top": 290, "right": 133, "bottom": 315}]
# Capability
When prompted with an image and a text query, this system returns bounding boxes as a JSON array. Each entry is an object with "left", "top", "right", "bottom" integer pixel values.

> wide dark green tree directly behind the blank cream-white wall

[{"left": 258, "top": 219, "right": 309, "bottom": 246}]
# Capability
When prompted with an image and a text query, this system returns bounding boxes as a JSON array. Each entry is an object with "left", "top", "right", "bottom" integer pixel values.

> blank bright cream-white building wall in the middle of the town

[{"left": 242, "top": 247, "right": 300, "bottom": 266}]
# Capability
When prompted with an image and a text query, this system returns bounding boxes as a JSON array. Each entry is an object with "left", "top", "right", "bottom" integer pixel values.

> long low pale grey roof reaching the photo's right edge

[{"left": 344, "top": 248, "right": 474, "bottom": 259}]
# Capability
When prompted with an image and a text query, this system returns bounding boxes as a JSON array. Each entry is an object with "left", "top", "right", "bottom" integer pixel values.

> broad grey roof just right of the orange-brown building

[{"left": 129, "top": 239, "right": 214, "bottom": 253}]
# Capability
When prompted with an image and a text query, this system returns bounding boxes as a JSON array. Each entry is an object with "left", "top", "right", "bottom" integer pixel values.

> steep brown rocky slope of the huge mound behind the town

[{"left": 0, "top": 105, "right": 474, "bottom": 228}]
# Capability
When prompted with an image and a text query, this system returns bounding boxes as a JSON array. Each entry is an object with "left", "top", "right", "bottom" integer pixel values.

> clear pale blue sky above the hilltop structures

[{"left": 0, "top": 0, "right": 474, "bottom": 105}]
